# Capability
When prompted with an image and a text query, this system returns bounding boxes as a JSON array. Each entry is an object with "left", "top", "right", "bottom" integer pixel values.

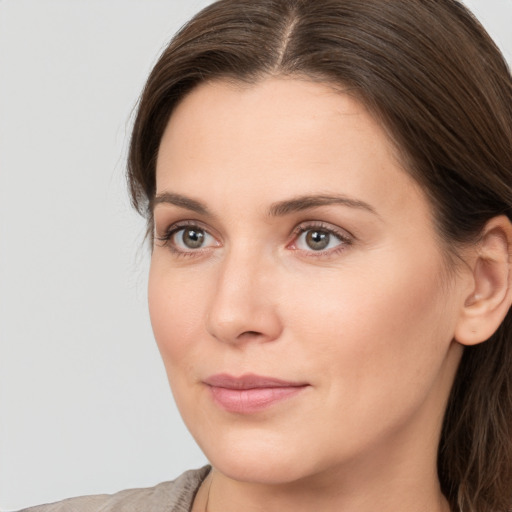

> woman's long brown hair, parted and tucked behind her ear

[{"left": 128, "top": 0, "right": 512, "bottom": 512}]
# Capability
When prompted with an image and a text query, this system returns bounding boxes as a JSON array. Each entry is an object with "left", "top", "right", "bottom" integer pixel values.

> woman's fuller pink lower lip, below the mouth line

[{"left": 210, "top": 386, "right": 307, "bottom": 414}]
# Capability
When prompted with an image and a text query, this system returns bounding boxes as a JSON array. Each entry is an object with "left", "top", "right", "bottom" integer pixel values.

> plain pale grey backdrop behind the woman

[{"left": 0, "top": 0, "right": 512, "bottom": 511}]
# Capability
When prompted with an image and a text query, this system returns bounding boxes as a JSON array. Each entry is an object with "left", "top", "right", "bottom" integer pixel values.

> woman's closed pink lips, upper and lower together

[{"left": 204, "top": 374, "right": 308, "bottom": 414}]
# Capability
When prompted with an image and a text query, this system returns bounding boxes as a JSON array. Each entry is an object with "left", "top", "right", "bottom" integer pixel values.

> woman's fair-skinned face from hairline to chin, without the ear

[{"left": 149, "top": 79, "right": 463, "bottom": 483}]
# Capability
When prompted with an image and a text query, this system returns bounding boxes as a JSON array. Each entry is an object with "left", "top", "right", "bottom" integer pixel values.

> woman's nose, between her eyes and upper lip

[{"left": 206, "top": 247, "right": 282, "bottom": 344}]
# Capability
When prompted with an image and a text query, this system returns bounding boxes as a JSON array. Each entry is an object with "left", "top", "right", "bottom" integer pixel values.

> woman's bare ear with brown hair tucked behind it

[{"left": 455, "top": 215, "right": 512, "bottom": 345}]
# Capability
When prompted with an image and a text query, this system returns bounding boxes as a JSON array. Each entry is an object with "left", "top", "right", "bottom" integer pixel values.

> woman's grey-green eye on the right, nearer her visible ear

[{"left": 290, "top": 224, "right": 352, "bottom": 255}]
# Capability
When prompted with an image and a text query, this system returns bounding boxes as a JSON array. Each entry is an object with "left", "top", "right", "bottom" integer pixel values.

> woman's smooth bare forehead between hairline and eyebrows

[{"left": 157, "top": 78, "right": 428, "bottom": 219}]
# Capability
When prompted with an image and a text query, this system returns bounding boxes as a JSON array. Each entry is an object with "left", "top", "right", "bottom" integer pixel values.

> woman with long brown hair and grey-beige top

[{"left": 22, "top": 0, "right": 512, "bottom": 512}]
